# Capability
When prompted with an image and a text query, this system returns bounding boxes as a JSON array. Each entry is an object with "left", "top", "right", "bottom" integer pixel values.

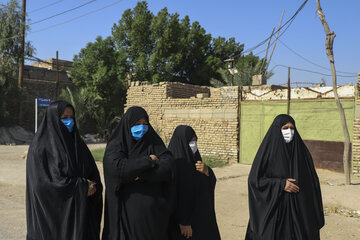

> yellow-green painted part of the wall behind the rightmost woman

[{"left": 240, "top": 99, "right": 355, "bottom": 169}]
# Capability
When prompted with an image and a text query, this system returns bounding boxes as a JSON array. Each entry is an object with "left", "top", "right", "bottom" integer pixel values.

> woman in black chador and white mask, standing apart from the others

[{"left": 245, "top": 114, "right": 324, "bottom": 240}]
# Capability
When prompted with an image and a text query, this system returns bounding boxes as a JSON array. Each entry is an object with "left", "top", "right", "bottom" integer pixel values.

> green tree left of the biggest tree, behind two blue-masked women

[{"left": 69, "top": 37, "right": 129, "bottom": 137}]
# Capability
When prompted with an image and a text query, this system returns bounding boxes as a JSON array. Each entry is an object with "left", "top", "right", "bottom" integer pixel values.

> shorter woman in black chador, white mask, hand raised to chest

[{"left": 169, "top": 125, "right": 220, "bottom": 240}]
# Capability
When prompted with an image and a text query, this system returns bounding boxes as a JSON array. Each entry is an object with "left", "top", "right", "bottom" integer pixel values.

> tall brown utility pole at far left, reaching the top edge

[{"left": 18, "top": 0, "right": 26, "bottom": 125}]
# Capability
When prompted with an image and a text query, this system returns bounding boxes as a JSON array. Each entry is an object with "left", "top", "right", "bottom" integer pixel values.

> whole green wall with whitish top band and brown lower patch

[{"left": 239, "top": 85, "right": 360, "bottom": 174}]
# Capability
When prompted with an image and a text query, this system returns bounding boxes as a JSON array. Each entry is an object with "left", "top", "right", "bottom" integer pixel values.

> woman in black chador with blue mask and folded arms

[{"left": 102, "top": 107, "right": 174, "bottom": 240}]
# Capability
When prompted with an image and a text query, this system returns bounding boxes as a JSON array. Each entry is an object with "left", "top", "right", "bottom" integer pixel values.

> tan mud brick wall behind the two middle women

[{"left": 126, "top": 82, "right": 239, "bottom": 163}]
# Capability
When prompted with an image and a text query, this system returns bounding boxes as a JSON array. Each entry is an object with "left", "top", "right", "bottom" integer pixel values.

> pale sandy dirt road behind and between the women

[{"left": 0, "top": 145, "right": 360, "bottom": 240}]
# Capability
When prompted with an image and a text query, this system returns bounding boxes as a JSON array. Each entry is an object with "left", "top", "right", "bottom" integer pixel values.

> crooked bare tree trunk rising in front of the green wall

[{"left": 316, "top": 0, "right": 351, "bottom": 185}]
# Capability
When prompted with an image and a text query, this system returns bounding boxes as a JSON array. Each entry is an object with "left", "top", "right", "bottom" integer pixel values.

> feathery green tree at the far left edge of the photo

[{"left": 0, "top": 0, "right": 34, "bottom": 125}]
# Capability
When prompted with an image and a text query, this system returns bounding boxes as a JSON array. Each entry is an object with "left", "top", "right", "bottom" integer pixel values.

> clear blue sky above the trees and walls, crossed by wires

[{"left": 0, "top": 0, "right": 360, "bottom": 85}]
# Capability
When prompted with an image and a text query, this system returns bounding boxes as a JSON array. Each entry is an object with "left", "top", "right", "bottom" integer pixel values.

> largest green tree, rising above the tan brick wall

[{"left": 112, "top": 1, "right": 238, "bottom": 85}]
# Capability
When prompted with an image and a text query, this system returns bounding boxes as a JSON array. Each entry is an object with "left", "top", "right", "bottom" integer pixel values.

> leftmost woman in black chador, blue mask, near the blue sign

[{"left": 26, "top": 101, "right": 102, "bottom": 240}]
